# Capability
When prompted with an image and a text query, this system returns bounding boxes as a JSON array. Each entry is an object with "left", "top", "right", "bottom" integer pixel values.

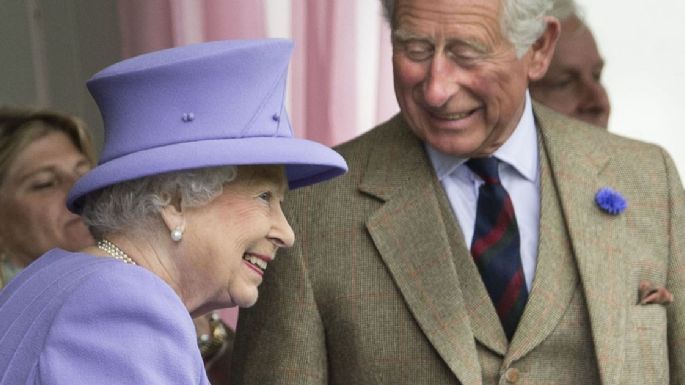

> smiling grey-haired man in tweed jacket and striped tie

[{"left": 231, "top": 0, "right": 685, "bottom": 385}]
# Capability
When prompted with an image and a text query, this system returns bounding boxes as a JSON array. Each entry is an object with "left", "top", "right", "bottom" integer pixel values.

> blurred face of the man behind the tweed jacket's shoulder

[{"left": 530, "top": 16, "right": 611, "bottom": 128}]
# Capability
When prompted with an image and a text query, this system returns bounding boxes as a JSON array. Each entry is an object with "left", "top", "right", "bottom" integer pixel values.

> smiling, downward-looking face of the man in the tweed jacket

[{"left": 393, "top": 0, "right": 553, "bottom": 157}]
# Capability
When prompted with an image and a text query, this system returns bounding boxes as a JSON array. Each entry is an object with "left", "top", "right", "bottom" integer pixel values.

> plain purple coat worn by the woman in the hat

[{"left": 0, "top": 249, "right": 209, "bottom": 385}]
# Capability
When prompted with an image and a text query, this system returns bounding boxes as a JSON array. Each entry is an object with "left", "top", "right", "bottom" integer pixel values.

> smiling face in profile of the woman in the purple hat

[{"left": 182, "top": 166, "right": 295, "bottom": 307}]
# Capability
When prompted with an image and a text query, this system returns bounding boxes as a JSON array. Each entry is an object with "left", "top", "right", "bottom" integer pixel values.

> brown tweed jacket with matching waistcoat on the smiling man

[{"left": 232, "top": 105, "right": 685, "bottom": 385}]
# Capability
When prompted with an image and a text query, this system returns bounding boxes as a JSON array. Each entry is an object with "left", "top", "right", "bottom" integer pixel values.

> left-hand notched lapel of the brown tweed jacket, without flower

[{"left": 360, "top": 117, "right": 482, "bottom": 385}]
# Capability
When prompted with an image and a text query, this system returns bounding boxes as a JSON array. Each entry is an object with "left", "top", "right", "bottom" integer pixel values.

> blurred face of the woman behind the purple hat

[{"left": 0, "top": 132, "right": 94, "bottom": 265}]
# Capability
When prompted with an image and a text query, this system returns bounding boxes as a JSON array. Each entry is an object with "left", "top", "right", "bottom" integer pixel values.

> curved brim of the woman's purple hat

[{"left": 67, "top": 137, "right": 347, "bottom": 214}]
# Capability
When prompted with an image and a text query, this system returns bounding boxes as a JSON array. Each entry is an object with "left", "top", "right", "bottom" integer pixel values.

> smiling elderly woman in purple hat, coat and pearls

[{"left": 0, "top": 40, "right": 347, "bottom": 384}]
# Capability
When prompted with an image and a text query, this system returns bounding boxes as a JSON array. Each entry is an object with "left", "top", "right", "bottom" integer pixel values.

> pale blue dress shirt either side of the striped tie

[{"left": 426, "top": 92, "right": 540, "bottom": 292}]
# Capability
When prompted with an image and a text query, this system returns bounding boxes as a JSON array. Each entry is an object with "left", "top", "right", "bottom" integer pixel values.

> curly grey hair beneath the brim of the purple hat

[{"left": 81, "top": 166, "right": 238, "bottom": 239}]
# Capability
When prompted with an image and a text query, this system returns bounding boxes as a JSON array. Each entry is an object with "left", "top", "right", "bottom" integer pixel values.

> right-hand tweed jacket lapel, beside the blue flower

[{"left": 536, "top": 106, "right": 627, "bottom": 385}]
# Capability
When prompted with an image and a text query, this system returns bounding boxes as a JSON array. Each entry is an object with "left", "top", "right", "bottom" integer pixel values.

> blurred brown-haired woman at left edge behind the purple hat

[{"left": 0, "top": 107, "right": 95, "bottom": 288}]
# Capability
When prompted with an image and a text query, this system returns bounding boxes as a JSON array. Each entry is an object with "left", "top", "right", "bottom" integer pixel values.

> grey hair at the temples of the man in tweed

[{"left": 381, "top": 0, "right": 554, "bottom": 57}]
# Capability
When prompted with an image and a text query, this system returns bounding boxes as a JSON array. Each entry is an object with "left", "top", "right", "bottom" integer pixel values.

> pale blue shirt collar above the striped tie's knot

[{"left": 425, "top": 91, "right": 538, "bottom": 182}]
